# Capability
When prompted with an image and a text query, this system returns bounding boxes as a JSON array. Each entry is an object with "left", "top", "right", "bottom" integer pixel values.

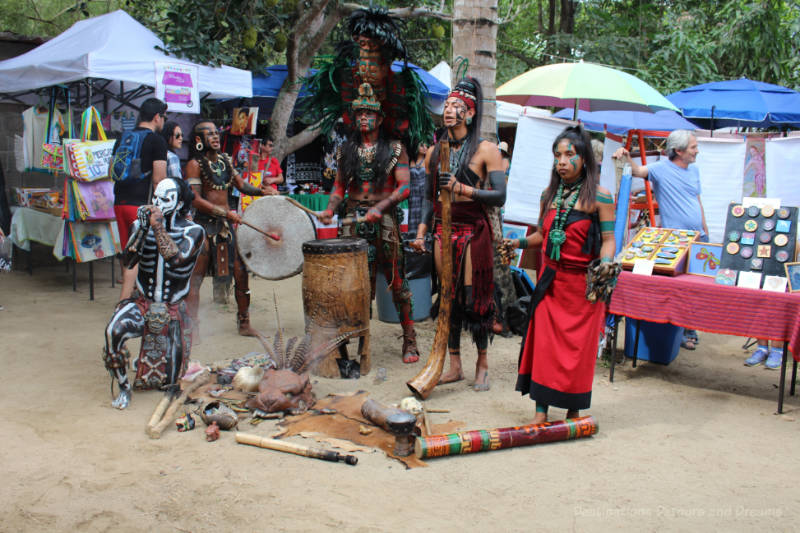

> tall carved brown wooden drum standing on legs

[{"left": 303, "top": 238, "right": 371, "bottom": 377}]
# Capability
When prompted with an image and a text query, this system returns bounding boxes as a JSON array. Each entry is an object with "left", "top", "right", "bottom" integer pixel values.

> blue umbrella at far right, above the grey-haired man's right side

[{"left": 667, "top": 78, "right": 800, "bottom": 128}]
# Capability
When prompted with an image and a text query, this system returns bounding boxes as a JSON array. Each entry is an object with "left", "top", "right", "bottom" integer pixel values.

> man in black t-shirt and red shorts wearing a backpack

[{"left": 114, "top": 98, "right": 167, "bottom": 300}]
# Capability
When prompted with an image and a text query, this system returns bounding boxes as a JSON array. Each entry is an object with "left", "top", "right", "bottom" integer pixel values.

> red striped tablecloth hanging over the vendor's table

[{"left": 609, "top": 272, "right": 800, "bottom": 361}]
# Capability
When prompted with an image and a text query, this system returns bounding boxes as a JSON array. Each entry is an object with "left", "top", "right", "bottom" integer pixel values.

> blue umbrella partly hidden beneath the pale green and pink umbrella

[{"left": 553, "top": 108, "right": 697, "bottom": 135}]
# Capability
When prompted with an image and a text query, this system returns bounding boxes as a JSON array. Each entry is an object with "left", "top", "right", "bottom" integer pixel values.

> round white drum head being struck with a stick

[{"left": 236, "top": 196, "right": 317, "bottom": 280}]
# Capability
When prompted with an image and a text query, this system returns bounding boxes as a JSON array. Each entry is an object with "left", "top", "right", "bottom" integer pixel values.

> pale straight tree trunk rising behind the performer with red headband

[{"left": 453, "top": 0, "right": 497, "bottom": 142}]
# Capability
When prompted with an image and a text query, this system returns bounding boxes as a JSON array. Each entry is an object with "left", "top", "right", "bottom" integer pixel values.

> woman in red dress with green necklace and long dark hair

[{"left": 516, "top": 126, "right": 615, "bottom": 424}]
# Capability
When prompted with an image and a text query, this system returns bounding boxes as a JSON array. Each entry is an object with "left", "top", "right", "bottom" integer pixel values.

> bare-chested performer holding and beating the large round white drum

[{"left": 186, "top": 121, "right": 277, "bottom": 336}]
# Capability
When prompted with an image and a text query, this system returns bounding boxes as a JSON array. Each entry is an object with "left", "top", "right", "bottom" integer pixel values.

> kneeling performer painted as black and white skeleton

[{"left": 104, "top": 178, "right": 205, "bottom": 409}]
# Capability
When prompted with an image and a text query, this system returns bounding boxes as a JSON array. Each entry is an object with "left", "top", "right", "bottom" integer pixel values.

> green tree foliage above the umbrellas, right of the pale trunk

[{"left": 497, "top": 0, "right": 800, "bottom": 93}]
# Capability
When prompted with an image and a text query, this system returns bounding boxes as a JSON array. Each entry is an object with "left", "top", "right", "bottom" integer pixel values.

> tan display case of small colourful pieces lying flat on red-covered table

[{"left": 622, "top": 227, "right": 699, "bottom": 276}]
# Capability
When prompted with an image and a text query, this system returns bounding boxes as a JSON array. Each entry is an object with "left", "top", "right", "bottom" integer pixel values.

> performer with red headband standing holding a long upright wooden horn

[{"left": 412, "top": 78, "right": 506, "bottom": 391}]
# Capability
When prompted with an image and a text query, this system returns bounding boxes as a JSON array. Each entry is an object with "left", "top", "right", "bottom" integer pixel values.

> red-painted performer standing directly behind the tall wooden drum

[{"left": 319, "top": 83, "right": 419, "bottom": 363}]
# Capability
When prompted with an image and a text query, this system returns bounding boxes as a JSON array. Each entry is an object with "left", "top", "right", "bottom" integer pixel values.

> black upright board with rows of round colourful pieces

[{"left": 721, "top": 202, "right": 797, "bottom": 281}]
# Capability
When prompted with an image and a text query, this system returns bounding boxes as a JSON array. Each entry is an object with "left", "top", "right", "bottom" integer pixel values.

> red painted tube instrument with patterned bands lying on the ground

[{"left": 414, "top": 416, "right": 597, "bottom": 459}]
